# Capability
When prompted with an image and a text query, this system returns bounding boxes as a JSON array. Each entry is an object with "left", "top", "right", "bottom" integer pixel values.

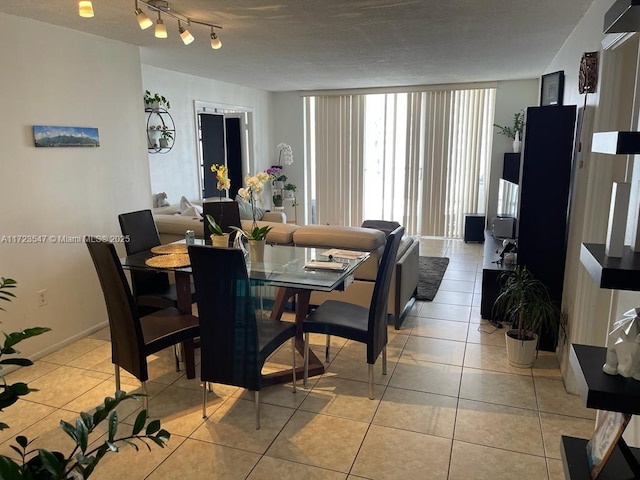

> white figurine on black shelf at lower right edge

[{"left": 602, "top": 308, "right": 640, "bottom": 380}]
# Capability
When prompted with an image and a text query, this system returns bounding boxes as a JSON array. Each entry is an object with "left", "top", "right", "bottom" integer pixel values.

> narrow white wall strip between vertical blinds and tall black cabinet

[{"left": 486, "top": 79, "right": 539, "bottom": 228}]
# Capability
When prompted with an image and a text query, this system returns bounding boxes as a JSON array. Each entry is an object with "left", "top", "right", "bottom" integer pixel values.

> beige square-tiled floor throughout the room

[{"left": 0, "top": 238, "right": 594, "bottom": 480}]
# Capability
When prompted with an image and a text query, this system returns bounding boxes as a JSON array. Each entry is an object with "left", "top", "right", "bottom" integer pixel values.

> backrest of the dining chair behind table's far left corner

[{"left": 118, "top": 210, "right": 169, "bottom": 297}]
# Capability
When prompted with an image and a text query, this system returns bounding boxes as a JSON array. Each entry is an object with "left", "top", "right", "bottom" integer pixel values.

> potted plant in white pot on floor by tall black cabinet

[{"left": 493, "top": 265, "right": 562, "bottom": 368}]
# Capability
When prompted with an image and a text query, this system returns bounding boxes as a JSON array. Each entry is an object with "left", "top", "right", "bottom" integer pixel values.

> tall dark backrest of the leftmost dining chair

[{"left": 85, "top": 237, "right": 149, "bottom": 381}]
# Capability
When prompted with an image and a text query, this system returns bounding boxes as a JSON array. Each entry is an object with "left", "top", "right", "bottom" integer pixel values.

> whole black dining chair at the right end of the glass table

[{"left": 302, "top": 227, "right": 404, "bottom": 400}]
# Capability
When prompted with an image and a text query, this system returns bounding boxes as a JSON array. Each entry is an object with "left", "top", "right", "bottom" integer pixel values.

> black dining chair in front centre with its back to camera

[{"left": 189, "top": 245, "right": 296, "bottom": 429}]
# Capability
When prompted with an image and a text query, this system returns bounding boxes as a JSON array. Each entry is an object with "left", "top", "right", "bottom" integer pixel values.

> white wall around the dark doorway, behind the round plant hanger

[{"left": 142, "top": 65, "right": 274, "bottom": 203}]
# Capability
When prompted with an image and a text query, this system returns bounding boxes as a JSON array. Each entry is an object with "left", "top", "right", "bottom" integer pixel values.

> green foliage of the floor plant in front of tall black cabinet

[{"left": 493, "top": 265, "right": 561, "bottom": 340}]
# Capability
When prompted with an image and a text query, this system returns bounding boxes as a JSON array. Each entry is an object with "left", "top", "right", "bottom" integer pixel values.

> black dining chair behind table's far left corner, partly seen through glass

[{"left": 118, "top": 210, "right": 195, "bottom": 313}]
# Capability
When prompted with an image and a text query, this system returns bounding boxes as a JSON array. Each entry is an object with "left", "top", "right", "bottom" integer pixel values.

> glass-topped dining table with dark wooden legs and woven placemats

[{"left": 120, "top": 239, "right": 369, "bottom": 385}]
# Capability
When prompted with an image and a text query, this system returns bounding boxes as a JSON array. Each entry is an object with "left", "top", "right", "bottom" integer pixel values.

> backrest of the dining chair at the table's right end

[{"left": 367, "top": 227, "right": 404, "bottom": 363}]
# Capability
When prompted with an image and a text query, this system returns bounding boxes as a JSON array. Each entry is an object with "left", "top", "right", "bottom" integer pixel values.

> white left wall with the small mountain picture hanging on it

[{"left": 0, "top": 14, "right": 150, "bottom": 357}]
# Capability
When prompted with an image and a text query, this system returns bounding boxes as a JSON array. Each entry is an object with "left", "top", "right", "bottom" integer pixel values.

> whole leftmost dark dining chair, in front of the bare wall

[{"left": 85, "top": 237, "right": 199, "bottom": 409}]
